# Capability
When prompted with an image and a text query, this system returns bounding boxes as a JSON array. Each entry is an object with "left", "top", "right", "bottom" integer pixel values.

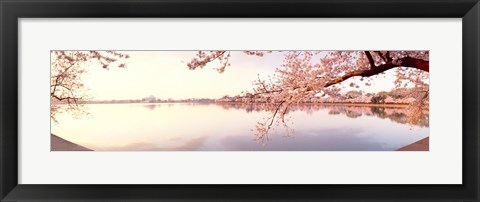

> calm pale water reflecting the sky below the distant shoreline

[{"left": 52, "top": 103, "right": 429, "bottom": 151}]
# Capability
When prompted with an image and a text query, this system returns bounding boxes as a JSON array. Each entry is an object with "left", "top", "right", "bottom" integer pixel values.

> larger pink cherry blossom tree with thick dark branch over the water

[{"left": 187, "top": 50, "right": 429, "bottom": 141}]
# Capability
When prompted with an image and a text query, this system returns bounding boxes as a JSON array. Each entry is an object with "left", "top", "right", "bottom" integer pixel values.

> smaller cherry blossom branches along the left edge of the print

[{"left": 50, "top": 50, "right": 128, "bottom": 122}]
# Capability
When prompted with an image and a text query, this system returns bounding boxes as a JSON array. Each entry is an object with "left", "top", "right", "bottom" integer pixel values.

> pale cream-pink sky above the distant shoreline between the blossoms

[{"left": 83, "top": 51, "right": 395, "bottom": 100}]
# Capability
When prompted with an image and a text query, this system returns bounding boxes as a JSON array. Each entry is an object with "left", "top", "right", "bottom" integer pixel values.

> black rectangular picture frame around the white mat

[{"left": 0, "top": 0, "right": 480, "bottom": 201}]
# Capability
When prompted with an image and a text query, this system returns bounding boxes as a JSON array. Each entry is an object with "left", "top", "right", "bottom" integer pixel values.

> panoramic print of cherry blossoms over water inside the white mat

[{"left": 50, "top": 50, "right": 430, "bottom": 152}]
